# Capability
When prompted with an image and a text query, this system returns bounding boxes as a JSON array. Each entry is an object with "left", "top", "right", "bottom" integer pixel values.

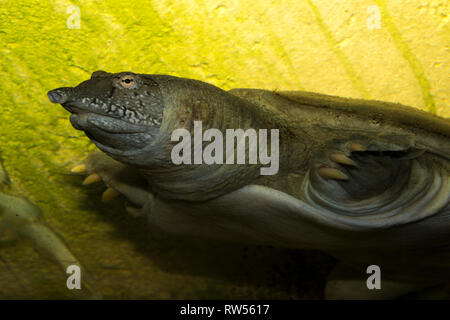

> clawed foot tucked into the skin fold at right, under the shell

[{"left": 311, "top": 135, "right": 425, "bottom": 201}]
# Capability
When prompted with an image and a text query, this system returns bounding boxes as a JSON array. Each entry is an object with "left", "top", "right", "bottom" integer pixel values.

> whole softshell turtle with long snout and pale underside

[{"left": 48, "top": 71, "right": 450, "bottom": 299}]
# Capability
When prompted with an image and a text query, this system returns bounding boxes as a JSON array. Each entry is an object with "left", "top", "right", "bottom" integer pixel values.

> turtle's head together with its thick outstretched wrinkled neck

[{"left": 48, "top": 71, "right": 268, "bottom": 200}]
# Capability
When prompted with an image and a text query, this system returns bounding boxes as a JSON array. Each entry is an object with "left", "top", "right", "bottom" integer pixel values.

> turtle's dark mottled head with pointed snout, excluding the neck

[{"left": 47, "top": 71, "right": 164, "bottom": 158}]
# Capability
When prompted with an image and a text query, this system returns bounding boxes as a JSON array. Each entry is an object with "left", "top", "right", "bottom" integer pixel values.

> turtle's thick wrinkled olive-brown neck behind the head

[{"left": 125, "top": 76, "right": 285, "bottom": 201}]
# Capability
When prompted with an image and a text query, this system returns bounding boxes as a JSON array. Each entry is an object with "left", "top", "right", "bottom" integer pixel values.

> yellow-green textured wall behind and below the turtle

[{"left": 0, "top": 0, "right": 450, "bottom": 298}]
